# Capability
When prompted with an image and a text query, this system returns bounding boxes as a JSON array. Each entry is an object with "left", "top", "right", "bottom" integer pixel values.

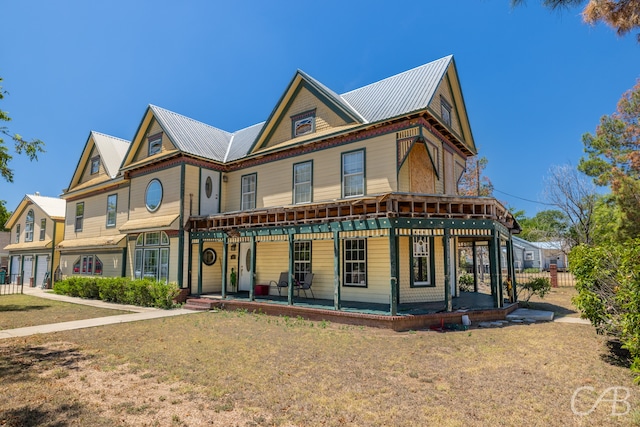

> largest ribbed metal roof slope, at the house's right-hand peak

[{"left": 341, "top": 55, "right": 453, "bottom": 122}]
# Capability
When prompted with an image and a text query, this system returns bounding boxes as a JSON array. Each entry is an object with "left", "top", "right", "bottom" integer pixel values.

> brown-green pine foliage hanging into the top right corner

[{"left": 511, "top": 0, "right": 640, "bottom": 42}]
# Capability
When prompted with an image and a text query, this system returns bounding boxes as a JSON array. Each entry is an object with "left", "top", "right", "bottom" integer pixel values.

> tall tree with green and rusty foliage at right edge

[{"left": 578, "top": 80, "right": 640, "bottom": 239}]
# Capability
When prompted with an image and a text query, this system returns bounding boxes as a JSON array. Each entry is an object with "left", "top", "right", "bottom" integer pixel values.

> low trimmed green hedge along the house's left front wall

[{"left": 53, "top": 276, "right": 179, "bottom": 308}]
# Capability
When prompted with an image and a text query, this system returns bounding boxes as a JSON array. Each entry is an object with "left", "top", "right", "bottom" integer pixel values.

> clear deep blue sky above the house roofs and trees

[{"left": 0, "top": 0, "right": 640, "bottom": 216}]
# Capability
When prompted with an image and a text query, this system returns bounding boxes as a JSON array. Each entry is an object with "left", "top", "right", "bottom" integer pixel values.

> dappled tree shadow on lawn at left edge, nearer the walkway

[{"left": 0, "top": 346, "right": 89, "bottom": 383}]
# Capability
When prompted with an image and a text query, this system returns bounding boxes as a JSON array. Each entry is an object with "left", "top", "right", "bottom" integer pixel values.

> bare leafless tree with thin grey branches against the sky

[{"left": 544, "top": 165, "right": 598, "bottom": 246}]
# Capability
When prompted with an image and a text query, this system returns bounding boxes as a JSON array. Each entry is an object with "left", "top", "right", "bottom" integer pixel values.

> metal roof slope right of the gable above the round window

[{"left": 149, "top": 105, "right": 232, "bottom": 162}]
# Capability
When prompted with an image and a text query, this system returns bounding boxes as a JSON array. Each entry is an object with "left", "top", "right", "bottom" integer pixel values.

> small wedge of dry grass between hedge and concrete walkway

[{"left": 0, "top": 295, "right": 130, "bottom": 330}]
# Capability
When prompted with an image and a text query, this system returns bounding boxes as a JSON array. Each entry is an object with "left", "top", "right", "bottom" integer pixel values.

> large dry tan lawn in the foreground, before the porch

[{"left": 0, "top": 289, "right": 640, "bottom": 426}]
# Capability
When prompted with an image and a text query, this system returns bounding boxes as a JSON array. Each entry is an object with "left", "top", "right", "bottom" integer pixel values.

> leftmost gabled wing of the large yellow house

[{"left": 57, "top": 132, "right": 129, "bottom": 277}]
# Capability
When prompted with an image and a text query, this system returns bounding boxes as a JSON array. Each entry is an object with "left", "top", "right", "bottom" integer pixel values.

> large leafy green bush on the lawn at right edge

[{"left": 569, "top": 239, "right": 640, "bottom": 380}]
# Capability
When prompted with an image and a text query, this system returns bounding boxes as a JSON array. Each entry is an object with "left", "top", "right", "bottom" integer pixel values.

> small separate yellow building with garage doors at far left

[{"left": 4, "top": 193, "right": 65, "bottom": 286}]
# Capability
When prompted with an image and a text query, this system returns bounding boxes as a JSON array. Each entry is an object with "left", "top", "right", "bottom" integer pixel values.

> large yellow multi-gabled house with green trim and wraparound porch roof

[{"left": 58, "top": 56, "right": 519, "bottom": 313}]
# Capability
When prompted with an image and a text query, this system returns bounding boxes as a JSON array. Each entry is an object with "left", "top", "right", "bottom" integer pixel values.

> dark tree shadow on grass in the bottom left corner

[{"left": 0, "top": 403, "right": 84, "bottom": 427}]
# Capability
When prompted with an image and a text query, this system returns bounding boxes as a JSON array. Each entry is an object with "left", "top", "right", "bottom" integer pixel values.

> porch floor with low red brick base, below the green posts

[{"left": 185, "top": 292, "right": 518, "bottom": 331}]
